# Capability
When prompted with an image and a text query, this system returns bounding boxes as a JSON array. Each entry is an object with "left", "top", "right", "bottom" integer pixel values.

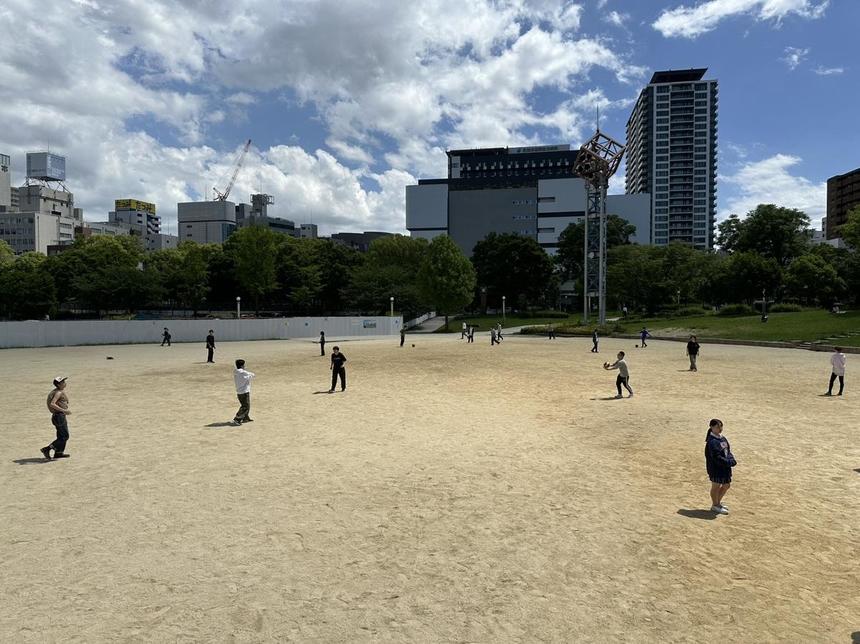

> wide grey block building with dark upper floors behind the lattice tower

[{"left": 406, "top": 146, "right": 651, "bottom": 256}]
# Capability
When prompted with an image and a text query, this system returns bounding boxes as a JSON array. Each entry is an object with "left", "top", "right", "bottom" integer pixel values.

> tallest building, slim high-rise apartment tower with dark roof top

[{"left": 625, "top": 68, "right": 717, "bottom": 248}]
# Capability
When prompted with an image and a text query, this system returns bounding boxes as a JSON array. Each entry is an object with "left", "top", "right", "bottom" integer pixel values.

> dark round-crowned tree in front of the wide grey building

[{"left": 472, "top": 233, "right": 553, "bottom": 307}]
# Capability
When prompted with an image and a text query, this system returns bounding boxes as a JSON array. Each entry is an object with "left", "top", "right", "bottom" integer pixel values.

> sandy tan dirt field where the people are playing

[{"left": 0, "top": 336, "right": 860, "bottom": 644}]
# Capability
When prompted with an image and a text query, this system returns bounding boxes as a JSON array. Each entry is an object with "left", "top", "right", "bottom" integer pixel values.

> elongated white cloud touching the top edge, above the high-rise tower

[{"left": 651, "top": 0, "right": 830, "bottom": 38}]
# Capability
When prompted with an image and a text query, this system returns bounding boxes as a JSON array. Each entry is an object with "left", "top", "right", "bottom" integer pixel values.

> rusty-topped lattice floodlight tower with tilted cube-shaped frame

[{"left": 573, "top": 128, "right": 624, "bottom": 324}]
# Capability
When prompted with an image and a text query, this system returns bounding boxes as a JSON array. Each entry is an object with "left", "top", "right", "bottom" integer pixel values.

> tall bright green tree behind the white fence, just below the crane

[{"left": 224, "top": 226, "right": 286, "bottom": 313}]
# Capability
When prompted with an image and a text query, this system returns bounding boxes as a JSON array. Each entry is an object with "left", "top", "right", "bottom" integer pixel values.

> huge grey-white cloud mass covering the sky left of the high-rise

[{"left": 0, "top": 0, "right": 644, "bottom": 232}]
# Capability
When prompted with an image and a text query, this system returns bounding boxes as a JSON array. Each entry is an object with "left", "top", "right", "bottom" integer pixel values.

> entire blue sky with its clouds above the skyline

[{"left": 0, "top": 0, "right": 860, "bottom": 233}]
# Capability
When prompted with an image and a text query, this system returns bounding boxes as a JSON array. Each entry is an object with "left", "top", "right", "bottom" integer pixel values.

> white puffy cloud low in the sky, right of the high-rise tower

[{"left": 719, "top": 154, "right": 827, "bottom": 225}]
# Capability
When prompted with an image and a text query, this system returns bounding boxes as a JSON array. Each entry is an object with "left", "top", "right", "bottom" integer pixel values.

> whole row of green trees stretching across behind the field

[{"left": 0, "top": 204, "right": 860, "bottom": 319}]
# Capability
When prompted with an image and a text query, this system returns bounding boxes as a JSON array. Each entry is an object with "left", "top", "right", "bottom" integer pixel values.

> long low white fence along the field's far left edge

[{"left": 0, "top": 316, "right": 403, "bottom": 349}]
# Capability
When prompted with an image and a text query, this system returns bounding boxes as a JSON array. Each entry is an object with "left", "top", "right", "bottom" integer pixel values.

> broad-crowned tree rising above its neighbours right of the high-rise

[{"left": 723, "top": 204, "right": 812, "bottom": 268}]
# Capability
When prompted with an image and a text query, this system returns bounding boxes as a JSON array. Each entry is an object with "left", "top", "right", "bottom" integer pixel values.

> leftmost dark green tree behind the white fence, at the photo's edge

[{"left": 0, "top": 253, "right": 57, "bottom": 320}]
